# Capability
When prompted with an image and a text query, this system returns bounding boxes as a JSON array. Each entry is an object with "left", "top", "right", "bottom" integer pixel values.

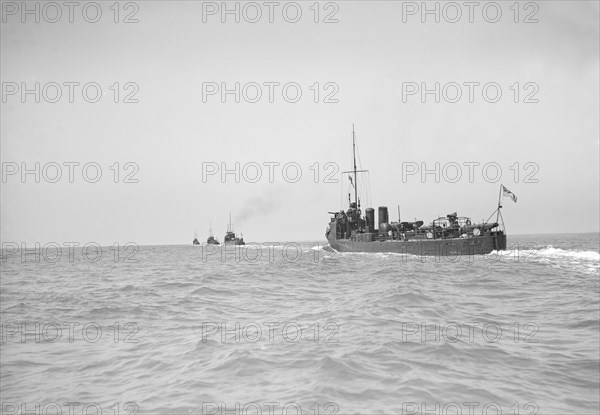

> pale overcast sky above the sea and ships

[{"left": 0, "top": 1, "right": 600, "bottom": 245}]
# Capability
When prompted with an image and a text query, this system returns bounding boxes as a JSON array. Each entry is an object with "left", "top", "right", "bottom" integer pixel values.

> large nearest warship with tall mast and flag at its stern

[{"left": 325, "top": 126, "right": 508, "bottom": 256}]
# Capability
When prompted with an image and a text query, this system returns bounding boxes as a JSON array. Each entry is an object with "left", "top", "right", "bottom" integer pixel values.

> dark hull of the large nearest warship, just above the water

[{"left": 327, "top": 231, "right": 506, "bottom": 256}]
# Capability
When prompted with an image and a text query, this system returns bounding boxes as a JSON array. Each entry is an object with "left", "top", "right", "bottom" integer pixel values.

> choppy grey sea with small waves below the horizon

[{"left": 0, "top": 233, "right": 600, "bottom": 415}]
